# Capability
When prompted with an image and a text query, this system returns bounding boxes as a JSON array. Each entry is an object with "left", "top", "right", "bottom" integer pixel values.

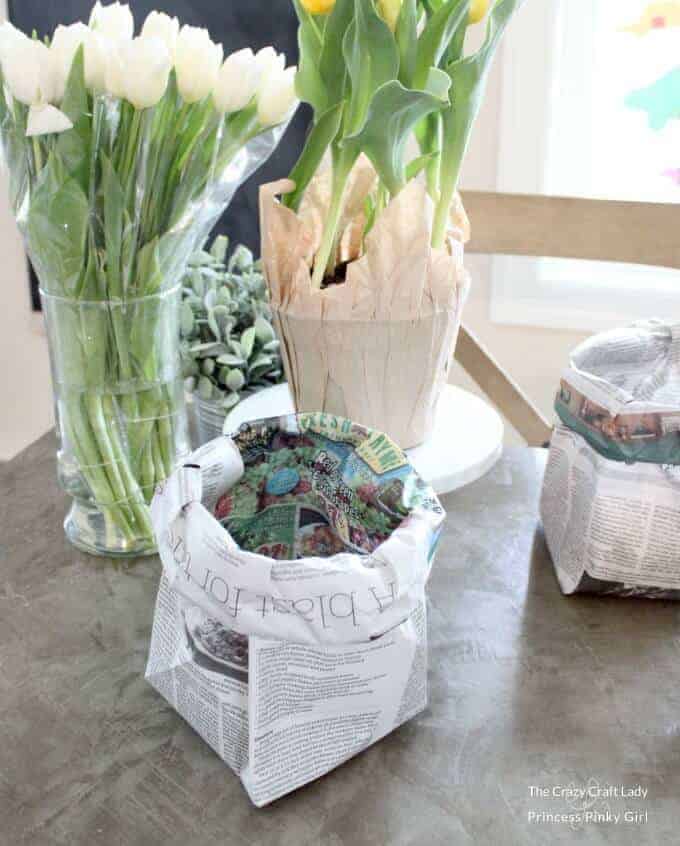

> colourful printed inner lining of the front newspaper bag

[{"left": 215, "top": 415, "right": 441, "bottom": 559}]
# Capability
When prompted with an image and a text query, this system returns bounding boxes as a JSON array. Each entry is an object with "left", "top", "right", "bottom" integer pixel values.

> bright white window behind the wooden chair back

[{"left": 491, "top": 0, "right": 680, "bottom": 330}]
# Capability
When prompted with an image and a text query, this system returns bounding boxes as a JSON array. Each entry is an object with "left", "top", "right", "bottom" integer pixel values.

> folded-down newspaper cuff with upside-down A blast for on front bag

[{"left": 151, "top": 437, "right": 436, "bottom": 644}]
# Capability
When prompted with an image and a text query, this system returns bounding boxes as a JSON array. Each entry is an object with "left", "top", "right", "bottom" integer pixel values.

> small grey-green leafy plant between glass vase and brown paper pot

[{"left": 180, "top": 236, "right": 283, "bottom": 409}]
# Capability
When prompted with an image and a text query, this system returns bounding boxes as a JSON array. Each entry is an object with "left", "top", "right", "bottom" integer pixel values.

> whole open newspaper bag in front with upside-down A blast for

[{"left": 147, "top": 414, "right": 444, "bottom": 806}]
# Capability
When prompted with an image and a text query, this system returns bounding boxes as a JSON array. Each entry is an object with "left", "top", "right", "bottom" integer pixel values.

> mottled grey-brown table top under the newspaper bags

[{"left": 0, "top": 436, "right": 680, "bottom": 846}]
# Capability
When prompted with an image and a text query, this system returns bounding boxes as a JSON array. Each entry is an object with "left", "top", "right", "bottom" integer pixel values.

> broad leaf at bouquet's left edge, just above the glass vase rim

[{"left": 27, "top": 152, "right": 90, "bottom": 296}]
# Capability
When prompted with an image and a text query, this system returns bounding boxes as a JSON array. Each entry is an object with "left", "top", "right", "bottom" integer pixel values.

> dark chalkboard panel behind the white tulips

[{"left": 9, "top": 0, "right": 308, "bottom": 253}]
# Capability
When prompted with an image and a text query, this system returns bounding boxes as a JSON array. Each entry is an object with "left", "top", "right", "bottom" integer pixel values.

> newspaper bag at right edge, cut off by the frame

[{"left": 541, "top": 320, "right": 680, "bottom": 599}]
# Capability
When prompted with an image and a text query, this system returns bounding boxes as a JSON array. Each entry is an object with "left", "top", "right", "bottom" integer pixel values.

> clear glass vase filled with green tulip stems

[{"left": 41, "top": 286, "right": 189, "bottom": 557}]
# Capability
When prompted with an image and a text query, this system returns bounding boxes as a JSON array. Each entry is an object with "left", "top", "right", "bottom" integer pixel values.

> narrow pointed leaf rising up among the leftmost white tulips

[{"left": 56, "top": 44, "right": 92, "bottom": 194}]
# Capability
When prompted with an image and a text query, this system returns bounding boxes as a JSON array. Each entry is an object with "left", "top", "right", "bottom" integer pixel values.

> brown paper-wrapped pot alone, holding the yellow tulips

[{"left": 260, "top": 160, "right": 469, "bottom": 449}]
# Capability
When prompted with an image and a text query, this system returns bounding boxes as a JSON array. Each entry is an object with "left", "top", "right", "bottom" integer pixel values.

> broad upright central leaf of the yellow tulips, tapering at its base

[{"left": 343, "top": 0, "right": 399, "bottom": 135}]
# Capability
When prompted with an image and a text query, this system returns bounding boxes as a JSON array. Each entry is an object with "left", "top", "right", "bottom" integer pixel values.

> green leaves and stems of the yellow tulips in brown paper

[{"left": 284, "top": 0, "right": 523, "bottom": 268}]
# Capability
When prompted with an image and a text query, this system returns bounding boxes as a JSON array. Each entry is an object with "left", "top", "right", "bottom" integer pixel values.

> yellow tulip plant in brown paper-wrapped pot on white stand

[{"left": 261, "top": 0, "right": 522, "bottom": 448}]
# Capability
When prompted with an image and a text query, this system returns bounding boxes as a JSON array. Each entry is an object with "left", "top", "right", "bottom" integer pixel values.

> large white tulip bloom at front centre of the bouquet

[{"left": 106, "top": 36, "right": 172, "bottom": 109}]
